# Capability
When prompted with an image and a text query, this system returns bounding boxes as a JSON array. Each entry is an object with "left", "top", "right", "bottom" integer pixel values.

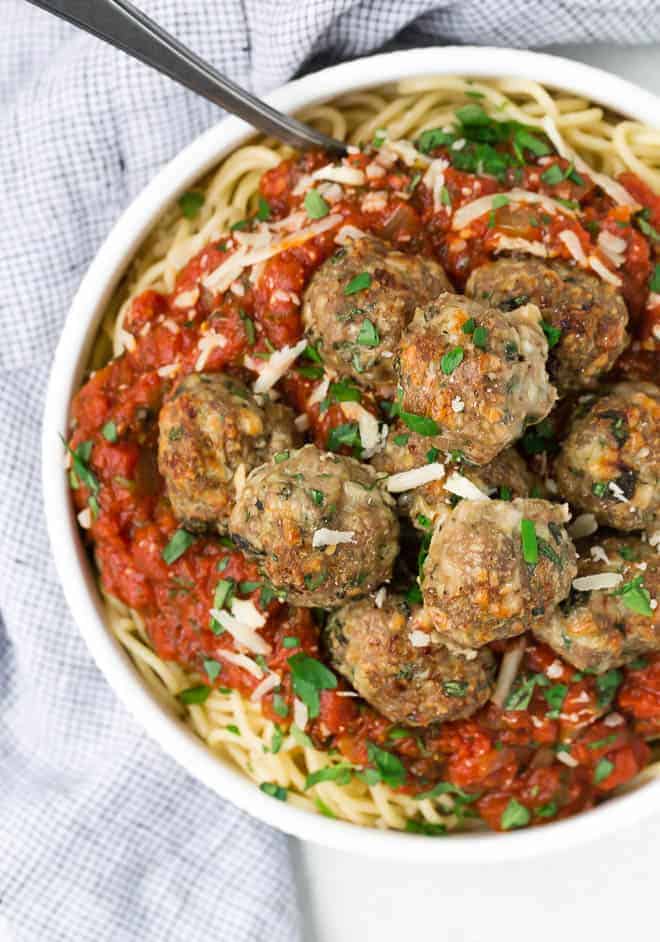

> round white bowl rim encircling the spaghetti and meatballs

[{"left": 42, "top": 46, "right": 660, "bottom": 861}]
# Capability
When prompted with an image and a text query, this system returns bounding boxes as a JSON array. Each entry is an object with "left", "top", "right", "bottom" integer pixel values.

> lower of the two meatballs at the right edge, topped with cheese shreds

[{"left": 532, "top": 536, "right": 660, "bottom": 674}]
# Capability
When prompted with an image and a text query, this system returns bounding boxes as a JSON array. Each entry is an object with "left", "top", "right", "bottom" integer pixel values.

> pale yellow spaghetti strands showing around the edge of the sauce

[{"left": 72, "top": 77, "right": 660, "bottom": 834}]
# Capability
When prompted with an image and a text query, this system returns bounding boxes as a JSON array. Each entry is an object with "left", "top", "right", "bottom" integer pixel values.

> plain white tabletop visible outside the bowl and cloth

[{"left": 291, "top": 45, "right": 660, "bottom": 942}]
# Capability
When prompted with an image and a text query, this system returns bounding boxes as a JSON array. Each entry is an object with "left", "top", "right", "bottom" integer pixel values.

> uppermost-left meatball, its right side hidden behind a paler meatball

[{"left": 302, "top": 237, "right": 451, "bottom": 395}]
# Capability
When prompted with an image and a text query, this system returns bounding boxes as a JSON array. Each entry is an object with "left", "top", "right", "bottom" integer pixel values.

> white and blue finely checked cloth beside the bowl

[{"left": 0, "top": 0, "right": 660, "bottom": 942}]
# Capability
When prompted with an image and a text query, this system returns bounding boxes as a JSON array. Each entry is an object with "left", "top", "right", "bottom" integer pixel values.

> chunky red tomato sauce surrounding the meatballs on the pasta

[{"left": 69, "top": 129, "right": 660, "bottom": 829}]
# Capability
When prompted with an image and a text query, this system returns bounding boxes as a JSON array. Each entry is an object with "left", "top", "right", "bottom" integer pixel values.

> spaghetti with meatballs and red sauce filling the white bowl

[{"left": 67, "top": 77, "right": 660, "bottom": 835}]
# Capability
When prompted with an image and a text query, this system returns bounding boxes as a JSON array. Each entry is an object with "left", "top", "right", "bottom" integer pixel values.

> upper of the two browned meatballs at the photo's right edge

[{"left": 555, "top": 383, "right": 660, "bottom": 530}]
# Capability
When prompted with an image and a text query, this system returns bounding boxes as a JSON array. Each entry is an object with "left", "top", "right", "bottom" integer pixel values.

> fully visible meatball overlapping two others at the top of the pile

[{"left": 397, "top": 294, "right": 556, "bottom": 464}]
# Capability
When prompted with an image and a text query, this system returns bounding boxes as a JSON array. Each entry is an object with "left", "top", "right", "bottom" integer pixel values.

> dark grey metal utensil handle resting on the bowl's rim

[{"left": 24, "top": 0, "right": 346, "bottom": 154}]
